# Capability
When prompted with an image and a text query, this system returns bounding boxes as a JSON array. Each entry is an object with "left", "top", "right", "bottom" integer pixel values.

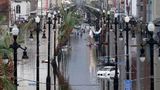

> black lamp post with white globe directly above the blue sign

[{"left": 124, "top": 16, "right": 130, "bottom": 80}]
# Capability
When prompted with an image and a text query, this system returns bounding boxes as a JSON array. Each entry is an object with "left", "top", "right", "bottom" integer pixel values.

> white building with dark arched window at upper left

[{"left": 11, "top": 1, "right": 31, "bottom": 21}]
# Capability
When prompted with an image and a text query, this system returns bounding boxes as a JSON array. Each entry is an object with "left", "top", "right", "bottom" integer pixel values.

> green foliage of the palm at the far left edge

[{"left": 0, "top": 31, "right": 15, "bottom": 90}]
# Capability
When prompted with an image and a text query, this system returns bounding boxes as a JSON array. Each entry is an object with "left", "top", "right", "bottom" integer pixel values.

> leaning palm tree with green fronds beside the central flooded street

[{"left": 52, "top": 6, "right": 81, "bottom": 90}]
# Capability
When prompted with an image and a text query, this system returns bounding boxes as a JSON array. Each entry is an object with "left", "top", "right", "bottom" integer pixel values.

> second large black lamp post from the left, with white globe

[{"left": 35, "top": 16, "right": 40, "bottom": 90}]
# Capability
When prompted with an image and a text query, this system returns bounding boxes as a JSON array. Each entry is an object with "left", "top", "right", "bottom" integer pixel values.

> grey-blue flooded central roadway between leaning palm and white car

[{"left": 65, "top": 30, "right": 100, "bottom": 90}]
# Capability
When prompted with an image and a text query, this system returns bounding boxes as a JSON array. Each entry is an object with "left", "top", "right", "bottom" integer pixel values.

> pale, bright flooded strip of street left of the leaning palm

[{"left": 17, "top": 33, "right": 48, "bottom": 90}]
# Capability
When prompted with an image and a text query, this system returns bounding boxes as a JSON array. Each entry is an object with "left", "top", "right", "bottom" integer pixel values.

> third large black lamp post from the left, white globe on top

[{"left": 46, "top": 13, "right": 52, "bottom": 90}]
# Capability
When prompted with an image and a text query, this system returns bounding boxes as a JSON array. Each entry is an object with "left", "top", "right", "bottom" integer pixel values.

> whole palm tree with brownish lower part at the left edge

[{"left": 0, "top": 31, "right": 15, "bottom": 90}]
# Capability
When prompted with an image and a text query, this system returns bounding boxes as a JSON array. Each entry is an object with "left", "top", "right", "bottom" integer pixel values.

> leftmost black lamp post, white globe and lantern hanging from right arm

[{"left": 10, "top": 25, "right": 28, "bottom": 90}]
